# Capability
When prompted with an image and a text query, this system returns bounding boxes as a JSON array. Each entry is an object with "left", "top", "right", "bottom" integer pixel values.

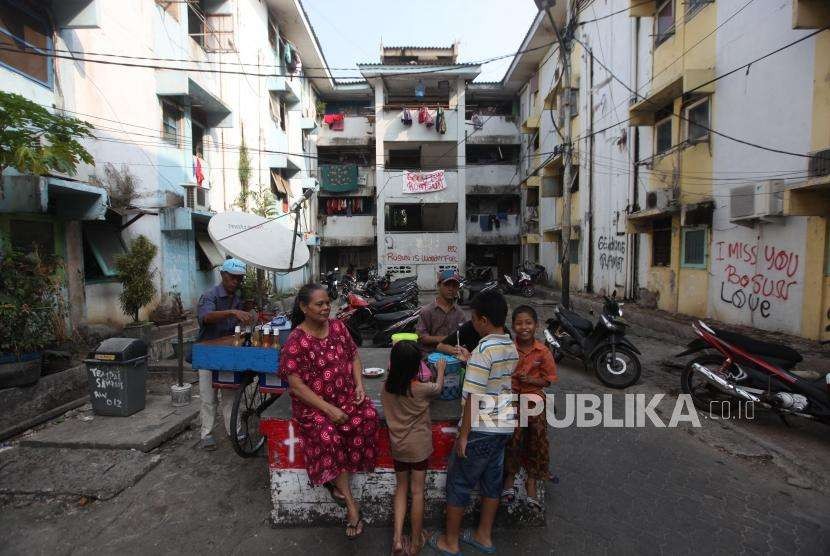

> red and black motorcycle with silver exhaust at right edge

[{"left": 677, "top": 320, "right": 830, "bottom": 424}]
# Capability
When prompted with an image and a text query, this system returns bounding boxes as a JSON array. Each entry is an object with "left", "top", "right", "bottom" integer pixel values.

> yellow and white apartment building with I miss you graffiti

[{"left": 520, "top": 0, "right": 830, "bottom": 339}]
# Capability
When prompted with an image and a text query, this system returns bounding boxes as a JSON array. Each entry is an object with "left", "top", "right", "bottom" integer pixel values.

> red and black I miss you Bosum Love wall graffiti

[{"left": 715, "top": 241, "right": 800, "bottom": 318}]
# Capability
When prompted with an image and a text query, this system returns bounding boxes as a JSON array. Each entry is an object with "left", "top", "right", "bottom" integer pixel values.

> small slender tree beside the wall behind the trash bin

[{"left": 115, "top": 235, "right": 158, "bottom": 322}]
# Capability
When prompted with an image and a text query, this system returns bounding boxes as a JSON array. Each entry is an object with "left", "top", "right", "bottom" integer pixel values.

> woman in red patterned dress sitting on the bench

[{"left": 280, "top": 284, "right": 378, "bottom": 539}]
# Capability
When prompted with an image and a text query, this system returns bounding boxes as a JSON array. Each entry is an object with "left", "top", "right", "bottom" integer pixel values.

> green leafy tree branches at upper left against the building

[{"left": 0, "top": 91, "right": 94, "bottom": 176}]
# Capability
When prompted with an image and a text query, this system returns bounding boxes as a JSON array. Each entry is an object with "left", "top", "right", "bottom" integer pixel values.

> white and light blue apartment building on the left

[{"left": 0, "top": 0, "right": 325, "bottom": 326}]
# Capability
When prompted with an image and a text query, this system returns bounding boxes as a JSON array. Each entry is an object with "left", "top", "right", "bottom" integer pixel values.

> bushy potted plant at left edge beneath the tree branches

[{"left": 0, "top": 249, "right": 65, "bottom": 388}]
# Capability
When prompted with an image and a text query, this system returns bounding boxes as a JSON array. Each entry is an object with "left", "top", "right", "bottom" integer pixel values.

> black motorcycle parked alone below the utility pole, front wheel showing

[{"left": 544, "top": 293, "right": 642, "bottom": 388}]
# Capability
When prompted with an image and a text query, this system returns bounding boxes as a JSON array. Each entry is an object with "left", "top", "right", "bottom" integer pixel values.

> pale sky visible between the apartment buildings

[{"left": 302, "top": 0, "right": 536, "bottom": 81}]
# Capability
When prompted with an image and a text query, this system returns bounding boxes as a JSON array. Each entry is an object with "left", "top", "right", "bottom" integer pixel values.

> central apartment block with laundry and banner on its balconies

[{"left": 317, "top": 44, "right": 520, "bottom": 288}]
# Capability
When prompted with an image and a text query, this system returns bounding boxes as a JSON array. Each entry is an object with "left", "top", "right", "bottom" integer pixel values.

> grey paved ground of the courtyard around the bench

[{"left": 0, "top": 294, "right": 830, "bottom": 554}]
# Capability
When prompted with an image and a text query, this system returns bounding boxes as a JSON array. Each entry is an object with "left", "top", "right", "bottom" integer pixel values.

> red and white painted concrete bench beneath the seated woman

[{"left": 260, "top": 379, "right": 545, "bottom": 527}]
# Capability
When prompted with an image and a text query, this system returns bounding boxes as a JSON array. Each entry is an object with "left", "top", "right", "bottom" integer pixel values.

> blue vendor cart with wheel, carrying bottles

[{"left": 193, "top": 336, "right": 288, "bottom": 458}]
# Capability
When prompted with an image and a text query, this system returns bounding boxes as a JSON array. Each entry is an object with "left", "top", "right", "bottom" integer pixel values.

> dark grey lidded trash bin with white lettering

[{"left": 84, "top": 338, "right": 147, "bottom": 417}]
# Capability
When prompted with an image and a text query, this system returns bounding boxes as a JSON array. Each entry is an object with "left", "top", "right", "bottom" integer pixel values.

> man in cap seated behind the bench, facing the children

[{"left": 415, "top": 270, "right": 467, "bottom": 353}]
